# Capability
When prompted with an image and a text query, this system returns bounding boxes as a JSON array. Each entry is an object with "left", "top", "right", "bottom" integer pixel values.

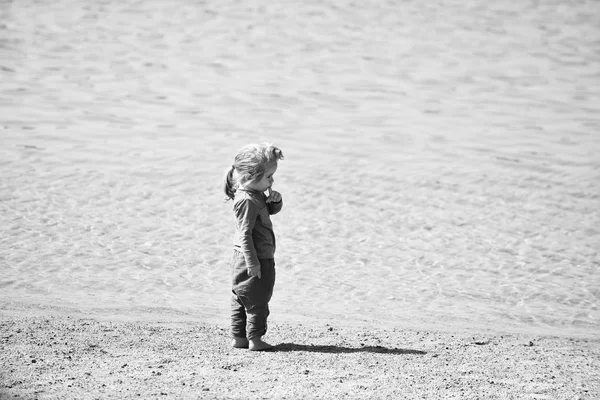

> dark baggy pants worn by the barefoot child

[{"left": 231, "top": 250, "right": 275, "bottom": 339}]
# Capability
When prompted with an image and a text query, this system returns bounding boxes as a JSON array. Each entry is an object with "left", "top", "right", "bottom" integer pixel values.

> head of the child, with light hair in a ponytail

[{"left": 224, "top": 143, "right": 283, "bottom": 199}]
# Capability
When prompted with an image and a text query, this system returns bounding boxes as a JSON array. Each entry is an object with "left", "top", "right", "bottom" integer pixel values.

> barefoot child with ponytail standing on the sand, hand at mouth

[{"left": 224, "top": 143, "right": 283, "bottom": 351}]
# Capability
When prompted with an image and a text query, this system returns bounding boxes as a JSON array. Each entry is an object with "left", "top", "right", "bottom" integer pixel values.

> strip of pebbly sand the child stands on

[{"left": 0, "top": 308, "right": 600, "bottom": 399}]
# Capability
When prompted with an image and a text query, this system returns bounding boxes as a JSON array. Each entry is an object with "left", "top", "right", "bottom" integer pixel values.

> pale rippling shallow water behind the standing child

[{"left": 0, "top": 0, "right": 600, "bottom": 336}]
